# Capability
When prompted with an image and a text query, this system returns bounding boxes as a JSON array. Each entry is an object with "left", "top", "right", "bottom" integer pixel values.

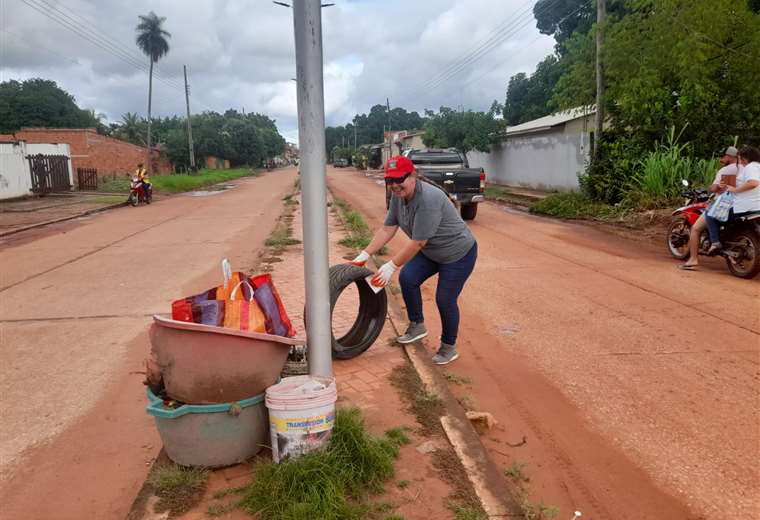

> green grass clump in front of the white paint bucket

[{"left": 239, "top": 408, "right": 400, "bottom": 520}]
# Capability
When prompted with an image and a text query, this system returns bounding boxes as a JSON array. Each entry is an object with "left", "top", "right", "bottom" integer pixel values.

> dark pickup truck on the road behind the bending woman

[{"left": 385, "top": 148, "right": 486, "bottom": 220}]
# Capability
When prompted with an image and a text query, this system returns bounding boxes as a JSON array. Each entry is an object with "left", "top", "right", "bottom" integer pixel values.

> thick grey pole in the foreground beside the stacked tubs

[{"left": 293, "top": 0, "right": 332, "bottom": 377}]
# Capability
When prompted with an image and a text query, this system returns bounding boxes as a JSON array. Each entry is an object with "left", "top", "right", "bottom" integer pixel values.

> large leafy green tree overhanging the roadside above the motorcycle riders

[{"left": 553, "top": 0, "right": 760, "bottom": 202}]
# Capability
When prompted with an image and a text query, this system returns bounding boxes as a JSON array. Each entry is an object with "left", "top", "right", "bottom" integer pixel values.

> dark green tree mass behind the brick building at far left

[{"left": 0, "top": 78, "right": 101, "bottom": 133}]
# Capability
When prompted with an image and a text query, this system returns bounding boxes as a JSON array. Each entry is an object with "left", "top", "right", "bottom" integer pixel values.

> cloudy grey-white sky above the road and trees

[{"left": 0, "top": 0, "right": 554, "bottom": 142}]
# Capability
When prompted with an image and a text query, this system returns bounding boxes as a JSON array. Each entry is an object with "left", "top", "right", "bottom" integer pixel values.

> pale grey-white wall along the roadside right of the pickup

[{"left": 467, "top": 125, "right": 589, "bottom": 191}]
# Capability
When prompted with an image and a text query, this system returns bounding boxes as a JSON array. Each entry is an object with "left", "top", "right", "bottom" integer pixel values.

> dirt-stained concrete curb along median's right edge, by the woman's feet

[{"left": 367, "top": 258, "right": 524, "bottom": 519}]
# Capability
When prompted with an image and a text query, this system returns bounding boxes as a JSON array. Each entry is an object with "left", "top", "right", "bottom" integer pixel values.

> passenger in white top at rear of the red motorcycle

[{"left": 705, "top": 146, "right": 760, "bottom": 253}]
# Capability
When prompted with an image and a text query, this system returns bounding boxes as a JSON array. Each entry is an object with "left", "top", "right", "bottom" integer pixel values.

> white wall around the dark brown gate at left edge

[{"left": 0, "top": 142, "right": 73, "bottom": 200}]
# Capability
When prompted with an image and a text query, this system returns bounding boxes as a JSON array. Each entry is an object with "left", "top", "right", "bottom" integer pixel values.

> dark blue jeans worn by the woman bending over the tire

[{"left": 399, "top": 243, "right": 478, "bottom": 345}]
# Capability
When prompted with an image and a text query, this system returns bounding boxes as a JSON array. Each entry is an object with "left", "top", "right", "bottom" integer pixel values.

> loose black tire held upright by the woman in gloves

[{"left": 304, "top": 264, "right": 388, "bottom": 359}]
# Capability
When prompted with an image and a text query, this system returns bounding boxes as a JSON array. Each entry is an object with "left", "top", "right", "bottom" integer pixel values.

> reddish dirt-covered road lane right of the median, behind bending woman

[{"left": 329, "top": 169, "right": 760, "bottom": 520}]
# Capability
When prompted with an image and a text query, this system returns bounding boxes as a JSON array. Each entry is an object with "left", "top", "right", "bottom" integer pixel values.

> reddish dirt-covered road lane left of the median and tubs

[{"left": 0, "top": 169, "right": 296, "bottom": 520}]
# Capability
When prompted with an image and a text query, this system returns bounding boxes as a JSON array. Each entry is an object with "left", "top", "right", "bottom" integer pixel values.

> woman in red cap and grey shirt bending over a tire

[{"left": 351, "top": 156, "right": 478, "bottom": 365}]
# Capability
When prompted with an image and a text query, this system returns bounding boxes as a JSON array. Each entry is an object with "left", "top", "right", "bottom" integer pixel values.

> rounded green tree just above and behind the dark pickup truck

[{"left": 423, "top": 103, "right": 503, "bottom": 154}]
